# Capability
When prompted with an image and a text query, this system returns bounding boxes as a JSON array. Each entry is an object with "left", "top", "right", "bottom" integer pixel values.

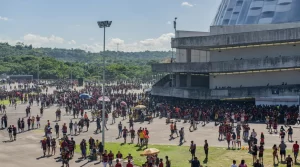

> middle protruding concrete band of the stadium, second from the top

[{"left": 152, "top": 55, "right": 300, "bottom": 73}]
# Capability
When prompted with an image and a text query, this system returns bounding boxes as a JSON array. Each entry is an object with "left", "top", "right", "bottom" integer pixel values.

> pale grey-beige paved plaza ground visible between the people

[{"left": 0, "top": 85, "right": 300, "bottom": 167}]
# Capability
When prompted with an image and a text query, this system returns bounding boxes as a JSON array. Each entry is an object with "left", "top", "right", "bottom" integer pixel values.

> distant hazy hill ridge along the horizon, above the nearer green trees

[{"left": 0, "top": 43, "right": 172, "bottom": 63}]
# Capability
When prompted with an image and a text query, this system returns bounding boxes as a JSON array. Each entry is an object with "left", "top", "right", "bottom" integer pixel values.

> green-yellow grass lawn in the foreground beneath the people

[{"left": 76, "top": 143, "right": 299, "bottom": 167}]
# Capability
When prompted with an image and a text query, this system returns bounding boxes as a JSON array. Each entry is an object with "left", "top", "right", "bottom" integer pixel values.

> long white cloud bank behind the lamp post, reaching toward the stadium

[{"left": 80, "top": 33, "right": 174, "bottom": 52}]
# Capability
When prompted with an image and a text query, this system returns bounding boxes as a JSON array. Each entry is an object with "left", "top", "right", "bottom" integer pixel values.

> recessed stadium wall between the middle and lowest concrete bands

[{"left": 209, "top": 71, "right": 300, "bottom": 89}]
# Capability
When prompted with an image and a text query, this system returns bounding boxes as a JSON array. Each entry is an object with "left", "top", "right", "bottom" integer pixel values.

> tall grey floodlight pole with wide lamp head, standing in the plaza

[{"left": 97, "top": 21, "right": 112, "bottom": 148}]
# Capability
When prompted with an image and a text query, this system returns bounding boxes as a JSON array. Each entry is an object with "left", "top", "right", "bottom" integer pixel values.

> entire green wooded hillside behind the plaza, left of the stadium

[{"left": 0, "top": 43, "right": 172, "bottom": 81}]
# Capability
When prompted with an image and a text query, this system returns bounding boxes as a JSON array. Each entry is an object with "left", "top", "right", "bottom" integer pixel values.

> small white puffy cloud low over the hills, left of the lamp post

[{"left": 23, "top": 34, "right": 64, "bottom": 47}]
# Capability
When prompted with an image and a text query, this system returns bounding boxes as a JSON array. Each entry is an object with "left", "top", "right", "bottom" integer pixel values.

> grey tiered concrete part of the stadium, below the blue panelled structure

[{"left": 151, "top": 20, "right": 300, "bottom": 99}]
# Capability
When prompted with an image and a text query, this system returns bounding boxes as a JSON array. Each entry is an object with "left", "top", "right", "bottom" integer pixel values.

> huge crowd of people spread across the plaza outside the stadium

[{"left": 0, "top": 78, "right": 299, "bottom": 167}]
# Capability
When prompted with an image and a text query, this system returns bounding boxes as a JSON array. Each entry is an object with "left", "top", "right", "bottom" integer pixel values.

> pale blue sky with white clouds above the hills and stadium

[{"left": 0, "top": 0, "right": 221, "bottom": 52}]
